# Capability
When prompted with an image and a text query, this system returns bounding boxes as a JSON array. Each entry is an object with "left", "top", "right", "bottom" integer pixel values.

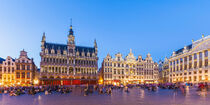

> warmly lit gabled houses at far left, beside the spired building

[{"left": 0, "top": 50, "right": 37, "bottom": 86}]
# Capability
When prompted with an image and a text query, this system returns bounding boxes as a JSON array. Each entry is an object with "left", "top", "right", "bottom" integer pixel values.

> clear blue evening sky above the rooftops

[{"left": 0, "top": 0, "right": 210, "bottom": 67}]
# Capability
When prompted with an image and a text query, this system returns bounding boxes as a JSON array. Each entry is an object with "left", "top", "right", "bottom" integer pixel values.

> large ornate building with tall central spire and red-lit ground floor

[{"left": 40, "top": 26, "right": 98, "bottom": 85}]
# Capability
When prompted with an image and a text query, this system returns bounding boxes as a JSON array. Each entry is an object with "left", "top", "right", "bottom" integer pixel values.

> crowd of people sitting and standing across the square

[{"left": 0, "top": 83, "right": 210, "bottom": 96}]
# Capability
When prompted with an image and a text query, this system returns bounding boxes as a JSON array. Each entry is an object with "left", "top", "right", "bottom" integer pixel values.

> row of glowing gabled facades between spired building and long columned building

[{"left": 100, "top": 50, "right": 159, "bottom": 85}]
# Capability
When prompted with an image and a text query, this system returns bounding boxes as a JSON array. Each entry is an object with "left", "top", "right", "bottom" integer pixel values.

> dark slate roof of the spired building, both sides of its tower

[{"left": 44, "top": 43, "right": 95, "bottom": 56}]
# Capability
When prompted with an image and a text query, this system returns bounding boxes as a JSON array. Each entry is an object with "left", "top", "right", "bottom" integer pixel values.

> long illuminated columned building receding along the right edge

[{"left": 169, "top": 35, "right": 210, "bottom": 83}]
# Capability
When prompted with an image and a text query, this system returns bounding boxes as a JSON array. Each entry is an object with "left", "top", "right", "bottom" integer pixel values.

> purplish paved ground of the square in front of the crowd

[{"left": 0, "top": 88, "right": 210, "bottom": 105}]
